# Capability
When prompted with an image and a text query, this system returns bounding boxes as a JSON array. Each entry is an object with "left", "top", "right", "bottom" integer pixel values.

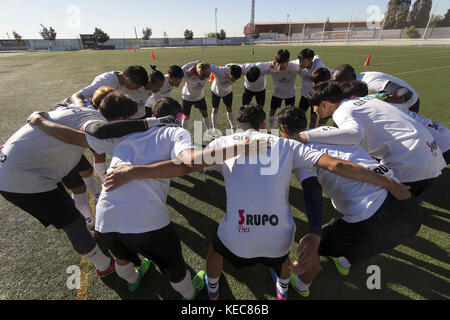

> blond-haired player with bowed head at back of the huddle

[{"left": 181, "top": 61, "right": 211, "bottom": 130}]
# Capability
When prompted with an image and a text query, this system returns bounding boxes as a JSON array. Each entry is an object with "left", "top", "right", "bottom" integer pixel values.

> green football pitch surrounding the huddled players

[{"left": 0, "top": 46, "right": 450, "bottom": 299}]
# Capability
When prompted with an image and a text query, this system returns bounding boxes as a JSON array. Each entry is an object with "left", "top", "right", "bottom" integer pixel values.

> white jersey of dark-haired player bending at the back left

[{"left": 79, "top": 71, "right": 147, "bottom": 119}]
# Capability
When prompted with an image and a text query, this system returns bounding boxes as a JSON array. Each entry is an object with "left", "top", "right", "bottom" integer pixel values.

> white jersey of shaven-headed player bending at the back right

[{"left": 356, "top": 71, "right": 419, "bottom": 112}]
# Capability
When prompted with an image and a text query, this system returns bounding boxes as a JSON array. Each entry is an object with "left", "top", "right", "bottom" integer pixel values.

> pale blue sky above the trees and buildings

[{"left": 0, "top": 0, "right": 450, "bottom": 39}]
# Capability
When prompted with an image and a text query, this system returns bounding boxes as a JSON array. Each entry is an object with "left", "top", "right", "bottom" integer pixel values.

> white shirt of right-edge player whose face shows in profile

[{"left": 326, "top": 98, "right": 446, "bottom": 182}]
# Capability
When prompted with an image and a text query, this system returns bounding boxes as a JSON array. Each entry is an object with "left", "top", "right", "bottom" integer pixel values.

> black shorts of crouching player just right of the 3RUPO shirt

[{"left": 319, "top": 194, "right": 422, "bottom": 264}]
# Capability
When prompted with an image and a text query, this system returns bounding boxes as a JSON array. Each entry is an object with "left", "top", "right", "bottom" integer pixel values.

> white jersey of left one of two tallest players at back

[{"left": 269, "top": 61, "right": 299, "bottom": 99}]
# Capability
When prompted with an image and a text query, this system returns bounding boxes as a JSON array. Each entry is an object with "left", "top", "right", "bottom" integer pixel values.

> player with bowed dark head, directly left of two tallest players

[{"left": 241, "top": 62, "right": 273, "bottom": 107}]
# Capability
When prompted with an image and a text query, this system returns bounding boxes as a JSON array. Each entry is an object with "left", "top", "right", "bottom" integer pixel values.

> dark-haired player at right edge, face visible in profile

[{"left": 297, "top": 82, "right": 446, "bottom": 197}]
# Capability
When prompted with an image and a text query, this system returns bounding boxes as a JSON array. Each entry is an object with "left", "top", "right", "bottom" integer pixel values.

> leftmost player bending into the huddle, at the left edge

[{"left": 0, "top": 91, "right": 142, "bottom": 277}]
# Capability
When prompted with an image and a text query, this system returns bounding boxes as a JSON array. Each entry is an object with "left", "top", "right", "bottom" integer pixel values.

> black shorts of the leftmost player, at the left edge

[{"left": 0, "top": 183, "right": 84, "bottom": 229}]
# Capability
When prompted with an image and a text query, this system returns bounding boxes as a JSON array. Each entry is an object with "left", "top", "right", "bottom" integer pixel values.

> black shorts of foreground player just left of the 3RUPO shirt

[{"left": 97, "top": 223, "right": 186, "bottom": 283}]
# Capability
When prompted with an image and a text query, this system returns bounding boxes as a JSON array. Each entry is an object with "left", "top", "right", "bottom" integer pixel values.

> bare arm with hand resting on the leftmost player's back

[{"left": 27, "top": 112, "right": 89, "bottom": 148}]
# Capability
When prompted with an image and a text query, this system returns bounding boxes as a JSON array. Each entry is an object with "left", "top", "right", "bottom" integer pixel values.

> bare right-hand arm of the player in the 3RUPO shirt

[{"left": 315, "top": 154, "right": 411, "bottom": 200}]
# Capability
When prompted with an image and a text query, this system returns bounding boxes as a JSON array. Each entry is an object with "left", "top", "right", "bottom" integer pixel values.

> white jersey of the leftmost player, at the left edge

[{"left": 0, "top": 105, "right": 106, "bottom": 193}]
